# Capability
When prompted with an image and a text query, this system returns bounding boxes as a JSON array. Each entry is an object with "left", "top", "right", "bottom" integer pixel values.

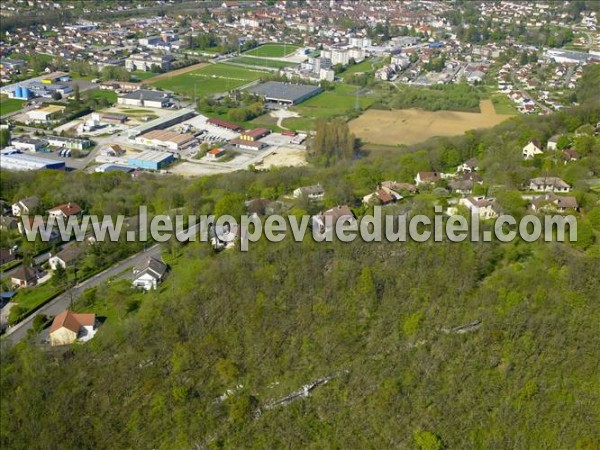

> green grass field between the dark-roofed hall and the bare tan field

[{"left": 283, "top": 84, "right": 375, "bottom": 130}]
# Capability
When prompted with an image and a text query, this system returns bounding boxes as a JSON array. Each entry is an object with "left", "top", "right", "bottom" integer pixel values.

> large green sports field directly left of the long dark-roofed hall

[{"left": 149, "top": 64, "right": 267, "bottom": 97}]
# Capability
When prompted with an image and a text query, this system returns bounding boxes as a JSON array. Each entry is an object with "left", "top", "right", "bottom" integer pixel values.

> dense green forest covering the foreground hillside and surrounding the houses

[{"left": 0, "top": 67, "right": 600, "bottom": 450}]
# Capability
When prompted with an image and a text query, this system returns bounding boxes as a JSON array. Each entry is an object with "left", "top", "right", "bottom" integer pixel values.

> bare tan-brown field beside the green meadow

[{"left": 349, "top": 100, "right": 511, "bottom": 145}]
